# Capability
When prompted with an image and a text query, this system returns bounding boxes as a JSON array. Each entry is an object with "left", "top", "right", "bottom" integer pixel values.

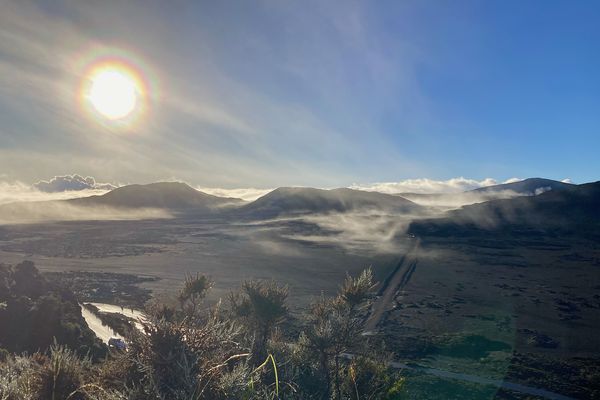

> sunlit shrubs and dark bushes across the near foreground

[{"left": 0, "top": 263, "right": 404, "bottom": 400}]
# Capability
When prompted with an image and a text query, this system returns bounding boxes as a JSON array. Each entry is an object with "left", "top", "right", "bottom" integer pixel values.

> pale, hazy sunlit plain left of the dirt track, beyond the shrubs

[{"left": 0, "top": 219, "right": 403, "bottom": 308}]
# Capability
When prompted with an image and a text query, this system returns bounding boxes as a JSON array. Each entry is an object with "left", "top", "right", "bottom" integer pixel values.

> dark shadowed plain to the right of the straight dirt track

[{"left": 379, "top": 238, "right": 600, "bottom": 398}]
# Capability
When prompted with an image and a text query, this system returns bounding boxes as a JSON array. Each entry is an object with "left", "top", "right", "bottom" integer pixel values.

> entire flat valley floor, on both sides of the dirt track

[{"left": 0, "top": 214, "right": 600, "bottom": 399}]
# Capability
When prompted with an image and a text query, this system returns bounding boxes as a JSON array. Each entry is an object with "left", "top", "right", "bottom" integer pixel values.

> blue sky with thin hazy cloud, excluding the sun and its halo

[{"left": 0, "top": 0, "right": 600, "bottom": 188}]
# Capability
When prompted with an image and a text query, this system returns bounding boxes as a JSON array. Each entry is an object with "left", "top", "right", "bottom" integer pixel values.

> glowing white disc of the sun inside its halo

[{"left": 87, "top": 69, "right": 138, "bottom": 120}]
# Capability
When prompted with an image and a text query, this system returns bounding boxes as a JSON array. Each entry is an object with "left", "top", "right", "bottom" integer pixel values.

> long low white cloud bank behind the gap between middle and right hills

[{"left": 350, "top": 176, "right": 521, "bottom": 193}]
